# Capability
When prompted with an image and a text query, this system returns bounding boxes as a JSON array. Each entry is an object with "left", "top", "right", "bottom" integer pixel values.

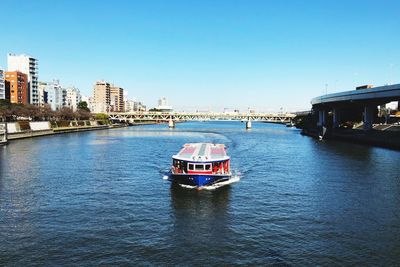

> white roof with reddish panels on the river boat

[{"left": 172, "top": 143, "right": 229, "bottom": 162}]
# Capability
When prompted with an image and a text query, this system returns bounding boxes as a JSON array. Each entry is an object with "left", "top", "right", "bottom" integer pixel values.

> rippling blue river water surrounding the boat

[{"left": 0, "top": 122, "right": 400, "bottom": 266}]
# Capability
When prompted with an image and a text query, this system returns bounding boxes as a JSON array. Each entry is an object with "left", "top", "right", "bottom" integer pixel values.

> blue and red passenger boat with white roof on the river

[{"left": 170, "top": 143, "right": 232, "bottom": 189}]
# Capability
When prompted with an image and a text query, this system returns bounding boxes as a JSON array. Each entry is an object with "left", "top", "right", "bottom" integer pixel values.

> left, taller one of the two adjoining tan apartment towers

[{"left": 92, "top": 81, "right": 111, "bottom": 113}]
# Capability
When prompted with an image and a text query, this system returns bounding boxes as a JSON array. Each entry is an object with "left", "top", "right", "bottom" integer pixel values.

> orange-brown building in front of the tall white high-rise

[{"left": 5, "top": 71, "right": 29, "bottom": 105}]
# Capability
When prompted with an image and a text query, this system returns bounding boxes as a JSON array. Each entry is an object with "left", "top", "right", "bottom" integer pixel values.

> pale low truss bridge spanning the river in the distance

[{"left": 108, "top": 112, "right": 296, "bottom": 128}]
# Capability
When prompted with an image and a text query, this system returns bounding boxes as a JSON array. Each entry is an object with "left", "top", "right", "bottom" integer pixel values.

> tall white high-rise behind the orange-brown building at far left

[{"left": 7, "top": 53, "right": 39, "bottom": 105}]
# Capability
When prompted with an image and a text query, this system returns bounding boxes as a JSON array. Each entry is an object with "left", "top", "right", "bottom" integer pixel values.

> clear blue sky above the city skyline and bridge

[{"left": 0, "top": 0, "right": 400, "bottom": 111}]
